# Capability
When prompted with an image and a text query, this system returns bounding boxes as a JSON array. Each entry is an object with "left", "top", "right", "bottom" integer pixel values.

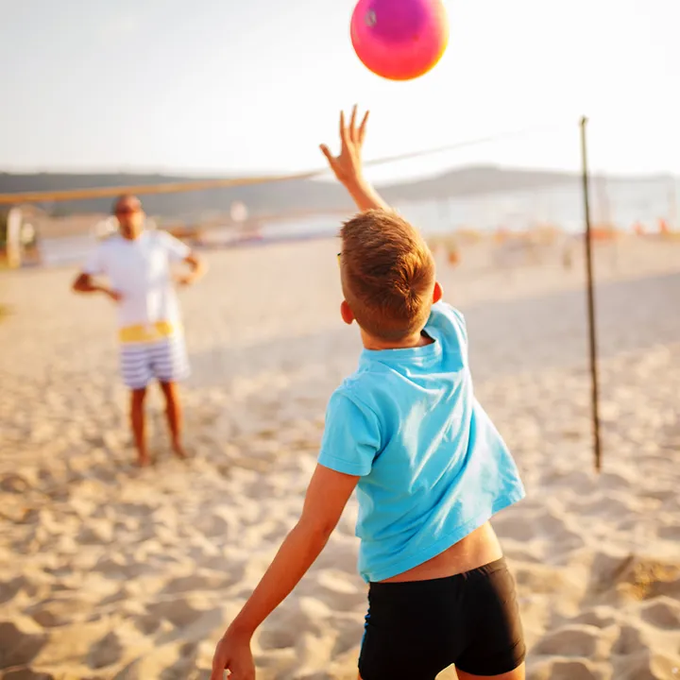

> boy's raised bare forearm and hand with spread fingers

[{"left": 321, "top": 106, "right": 391, "bottom": 211}]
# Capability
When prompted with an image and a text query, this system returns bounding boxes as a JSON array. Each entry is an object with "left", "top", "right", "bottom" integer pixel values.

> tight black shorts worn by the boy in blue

[{"left": 359, "top": 558, "right": 526, "bottom": 680}]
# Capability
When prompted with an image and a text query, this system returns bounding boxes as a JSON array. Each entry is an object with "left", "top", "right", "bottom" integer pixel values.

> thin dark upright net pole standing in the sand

[{"left": 581, "top": 116, "right": 602, "bottom": 472}]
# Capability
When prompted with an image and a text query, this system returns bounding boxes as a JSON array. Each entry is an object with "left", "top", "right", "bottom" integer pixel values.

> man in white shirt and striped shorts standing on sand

[{"left": 73, "top": 195, "right": 205, "bottom": 467}]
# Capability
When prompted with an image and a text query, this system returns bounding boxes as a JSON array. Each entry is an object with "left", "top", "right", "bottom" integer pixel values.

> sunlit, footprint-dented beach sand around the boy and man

[{"left": 0, "top": 238, "right": 680, "bottom": 680}]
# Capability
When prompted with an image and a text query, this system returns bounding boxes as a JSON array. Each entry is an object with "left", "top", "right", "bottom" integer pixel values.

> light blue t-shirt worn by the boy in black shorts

[{"left": 319, "top": 303, "right": 524, "bottom": 582}]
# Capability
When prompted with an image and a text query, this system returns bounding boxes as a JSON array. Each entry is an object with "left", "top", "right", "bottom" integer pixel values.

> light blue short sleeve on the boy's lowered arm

[{"left": 318, "top": 391, "right": 380, "bottom": 477}]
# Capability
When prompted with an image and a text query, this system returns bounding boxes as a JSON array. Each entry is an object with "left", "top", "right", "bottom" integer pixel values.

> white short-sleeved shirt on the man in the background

[{"left": 83, "top": 230, "right": 190, "bottom": 339}]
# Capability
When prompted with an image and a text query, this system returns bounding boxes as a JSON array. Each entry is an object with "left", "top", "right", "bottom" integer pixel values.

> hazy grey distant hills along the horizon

[{"left": 0, "top": 166, "right": 668, "bottom": 219}]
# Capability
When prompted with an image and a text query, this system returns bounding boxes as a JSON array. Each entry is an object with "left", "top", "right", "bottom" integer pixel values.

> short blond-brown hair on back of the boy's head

[{"left": 340, "top": 210, "right": 435, "bottom": 342}]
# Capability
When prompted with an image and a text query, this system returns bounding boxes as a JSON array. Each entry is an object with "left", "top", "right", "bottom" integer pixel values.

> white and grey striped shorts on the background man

[{"left": 120, "top": 333, "right": 190, "bottom": 390}]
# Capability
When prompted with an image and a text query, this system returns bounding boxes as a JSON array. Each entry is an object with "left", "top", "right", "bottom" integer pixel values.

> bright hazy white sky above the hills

[{"left": 0, "top": 0, "right": 680, "bottom": 181}]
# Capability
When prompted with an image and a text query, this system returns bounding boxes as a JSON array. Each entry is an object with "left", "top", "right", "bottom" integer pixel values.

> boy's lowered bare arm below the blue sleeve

[{"left": 211, "top": 465, "right": 359, "bottom": 680}]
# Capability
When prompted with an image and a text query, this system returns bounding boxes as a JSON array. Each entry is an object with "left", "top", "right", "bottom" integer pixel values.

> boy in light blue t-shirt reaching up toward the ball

[{"left": 211, "top": 107, "right": 525, "bottom": 680}]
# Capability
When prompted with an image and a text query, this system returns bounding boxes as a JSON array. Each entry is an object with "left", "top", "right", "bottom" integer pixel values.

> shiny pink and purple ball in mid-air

[{"left": 351, "top": 0, "right": 449, "bottom": 80}]
